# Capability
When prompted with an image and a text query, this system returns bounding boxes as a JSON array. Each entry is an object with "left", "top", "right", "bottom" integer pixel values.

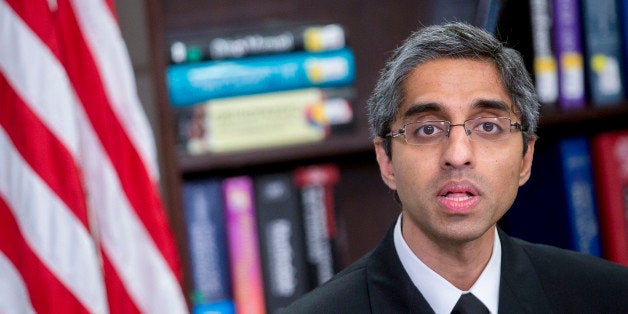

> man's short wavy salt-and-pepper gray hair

[{"left": 367, "top": 22, "right": 540, "bottom": 156}]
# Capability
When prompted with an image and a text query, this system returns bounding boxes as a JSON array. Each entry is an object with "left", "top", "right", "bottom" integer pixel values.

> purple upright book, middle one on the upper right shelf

[{"left": 552, "top": 0, "right": 587, "bottom": 110}]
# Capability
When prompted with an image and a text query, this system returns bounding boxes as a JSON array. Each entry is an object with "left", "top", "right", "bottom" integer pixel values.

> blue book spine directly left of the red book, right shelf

[{"left": 560, "top": 137, "right": 602, "bottom": 257}]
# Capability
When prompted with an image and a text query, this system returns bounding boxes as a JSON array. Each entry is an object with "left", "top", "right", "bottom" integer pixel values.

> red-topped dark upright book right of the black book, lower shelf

[{"left": 294, "top": 164, "right": 339, "bottom": 288}]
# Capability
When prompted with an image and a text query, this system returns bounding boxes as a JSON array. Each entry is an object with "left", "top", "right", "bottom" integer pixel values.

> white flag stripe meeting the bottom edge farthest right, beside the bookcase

[{"left": 78, "top": 101, "right": 187, "bottom": 313}]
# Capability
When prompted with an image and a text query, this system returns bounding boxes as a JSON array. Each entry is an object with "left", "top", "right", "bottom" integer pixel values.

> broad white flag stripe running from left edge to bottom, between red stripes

[{"left": 0, "top": 128, "right": 108, "bottom": 313}]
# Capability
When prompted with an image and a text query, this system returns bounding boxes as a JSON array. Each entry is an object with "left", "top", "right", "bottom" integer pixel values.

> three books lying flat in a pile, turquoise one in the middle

[{"left": 166, "top": 23, "right": 356, "bottom": 154}]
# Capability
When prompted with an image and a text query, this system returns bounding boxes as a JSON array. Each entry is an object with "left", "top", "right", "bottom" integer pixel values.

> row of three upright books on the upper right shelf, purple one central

[{"left": 529, "top": 0, "right": 628, "bottom": 110}]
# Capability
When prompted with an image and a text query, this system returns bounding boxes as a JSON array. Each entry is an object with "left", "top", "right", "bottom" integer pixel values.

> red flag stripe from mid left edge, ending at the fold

[{"left": 0, "top": 72, "right": 89, "bottom": 230}]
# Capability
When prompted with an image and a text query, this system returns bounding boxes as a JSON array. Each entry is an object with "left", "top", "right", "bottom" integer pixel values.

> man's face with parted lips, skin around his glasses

[{"left": 375, "top": 59, "right": 534, "bottom": 245}]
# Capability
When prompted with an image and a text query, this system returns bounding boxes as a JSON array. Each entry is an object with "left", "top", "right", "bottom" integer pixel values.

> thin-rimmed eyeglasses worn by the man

[{"left": 386, "top": 117, "right": 523, "bottom": 145}]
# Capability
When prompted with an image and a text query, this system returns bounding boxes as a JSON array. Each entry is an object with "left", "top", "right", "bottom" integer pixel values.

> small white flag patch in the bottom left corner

[{"left": 0, "top": 251, "right": 35, "bottom": 314}]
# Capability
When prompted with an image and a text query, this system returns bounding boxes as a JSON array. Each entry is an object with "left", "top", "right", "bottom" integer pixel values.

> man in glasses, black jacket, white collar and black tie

[{"left": 286, "top": 23, "right": 628, "bottom": 313}]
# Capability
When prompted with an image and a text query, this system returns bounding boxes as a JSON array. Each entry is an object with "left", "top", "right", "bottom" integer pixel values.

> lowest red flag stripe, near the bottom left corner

[{"left": 0, "top": 195, "right": 88, "bottom": 313}]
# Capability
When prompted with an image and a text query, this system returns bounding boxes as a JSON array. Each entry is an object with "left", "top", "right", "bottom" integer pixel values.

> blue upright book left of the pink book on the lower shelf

[{"left": 182, "top": 179, "right": 232, "bottom": 305}]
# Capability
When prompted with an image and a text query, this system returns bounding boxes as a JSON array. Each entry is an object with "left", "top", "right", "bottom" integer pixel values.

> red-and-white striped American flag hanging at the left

[{"left": 0, "top": 0, "right": 187, "bottom": 313}]
